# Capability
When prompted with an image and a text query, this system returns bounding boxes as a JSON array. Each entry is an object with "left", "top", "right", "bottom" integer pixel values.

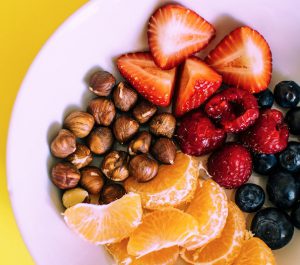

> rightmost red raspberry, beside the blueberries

[{"left": 241, "top": 109, "right": 289, "bottom": 154}]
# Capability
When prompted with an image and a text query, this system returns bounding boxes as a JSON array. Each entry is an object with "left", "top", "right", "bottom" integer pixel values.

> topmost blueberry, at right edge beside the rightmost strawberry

[{"left": 274, "top": 81, "right": 300, "bottom": 108}]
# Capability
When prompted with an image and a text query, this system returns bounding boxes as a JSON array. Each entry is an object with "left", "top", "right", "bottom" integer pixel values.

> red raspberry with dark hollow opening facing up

[{"left": 205, "top": 88, "right": 259, "bottom": 133}]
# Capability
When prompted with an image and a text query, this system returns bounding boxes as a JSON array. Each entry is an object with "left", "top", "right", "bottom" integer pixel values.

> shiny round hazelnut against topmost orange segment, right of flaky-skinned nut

[{"left": 129, "top": 155, "right": 158, "bottom": 182}]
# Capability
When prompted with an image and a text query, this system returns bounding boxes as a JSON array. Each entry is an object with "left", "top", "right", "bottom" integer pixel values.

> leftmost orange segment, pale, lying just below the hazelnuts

[{"left": 64, "top": 193, "right": 143, "bottom": 245}]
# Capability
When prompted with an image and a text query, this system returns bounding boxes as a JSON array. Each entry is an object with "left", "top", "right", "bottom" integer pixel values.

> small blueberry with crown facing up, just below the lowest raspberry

[{"left": 235, "top": 183, "right": 265, "bottom": 213}]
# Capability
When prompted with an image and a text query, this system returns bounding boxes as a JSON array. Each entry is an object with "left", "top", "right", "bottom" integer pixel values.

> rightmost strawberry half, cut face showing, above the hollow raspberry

[{"left": 206, "top": 27, "right": 272, "bottom": 93}]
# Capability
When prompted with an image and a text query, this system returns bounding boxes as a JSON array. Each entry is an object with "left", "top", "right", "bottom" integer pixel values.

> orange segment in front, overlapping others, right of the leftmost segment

[{"left": 127, "top": 208, "right": 199, "bottom": 257}]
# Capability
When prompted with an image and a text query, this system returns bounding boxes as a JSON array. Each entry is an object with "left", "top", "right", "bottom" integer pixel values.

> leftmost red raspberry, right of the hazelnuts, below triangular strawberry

[{"left": 177, "top": 112, "right": 226, "bottom": 156}]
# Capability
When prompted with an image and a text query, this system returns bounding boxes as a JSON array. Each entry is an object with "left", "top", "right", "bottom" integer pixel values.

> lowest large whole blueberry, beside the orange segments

[{"left": 251, "top": 207, "right": 294, "bottom": 249}]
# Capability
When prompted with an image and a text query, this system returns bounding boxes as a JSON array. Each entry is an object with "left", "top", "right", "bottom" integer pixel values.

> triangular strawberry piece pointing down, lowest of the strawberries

[{"left": 174, "top": 57, "right": 222, "bottom": 116}]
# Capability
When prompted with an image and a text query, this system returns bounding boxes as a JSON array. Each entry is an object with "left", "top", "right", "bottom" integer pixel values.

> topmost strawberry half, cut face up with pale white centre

[{"left": 148, "top": 4, "right": 215, "bottom": 69}]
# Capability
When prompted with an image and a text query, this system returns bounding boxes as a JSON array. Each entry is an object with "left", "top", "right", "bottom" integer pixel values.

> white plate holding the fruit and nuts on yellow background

[{"left": 7, "top": 0, "right": 300, "bottom": 265}]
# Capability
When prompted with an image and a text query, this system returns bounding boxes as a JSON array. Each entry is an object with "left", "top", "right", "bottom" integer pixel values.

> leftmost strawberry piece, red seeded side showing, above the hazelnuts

[{"left": 117, "top": 52, "right": 176, "bottom": 107}]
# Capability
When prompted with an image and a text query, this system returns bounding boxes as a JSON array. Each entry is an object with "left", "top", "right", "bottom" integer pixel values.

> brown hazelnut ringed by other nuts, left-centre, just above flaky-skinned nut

[{"left": 87, "top": 127, "right": 114, "bottom": 155}]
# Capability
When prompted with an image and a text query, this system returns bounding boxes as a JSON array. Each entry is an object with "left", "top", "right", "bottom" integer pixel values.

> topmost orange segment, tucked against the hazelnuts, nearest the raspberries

[{"left": 124, "top": 152, "right": 199, "bottom": 209}]
